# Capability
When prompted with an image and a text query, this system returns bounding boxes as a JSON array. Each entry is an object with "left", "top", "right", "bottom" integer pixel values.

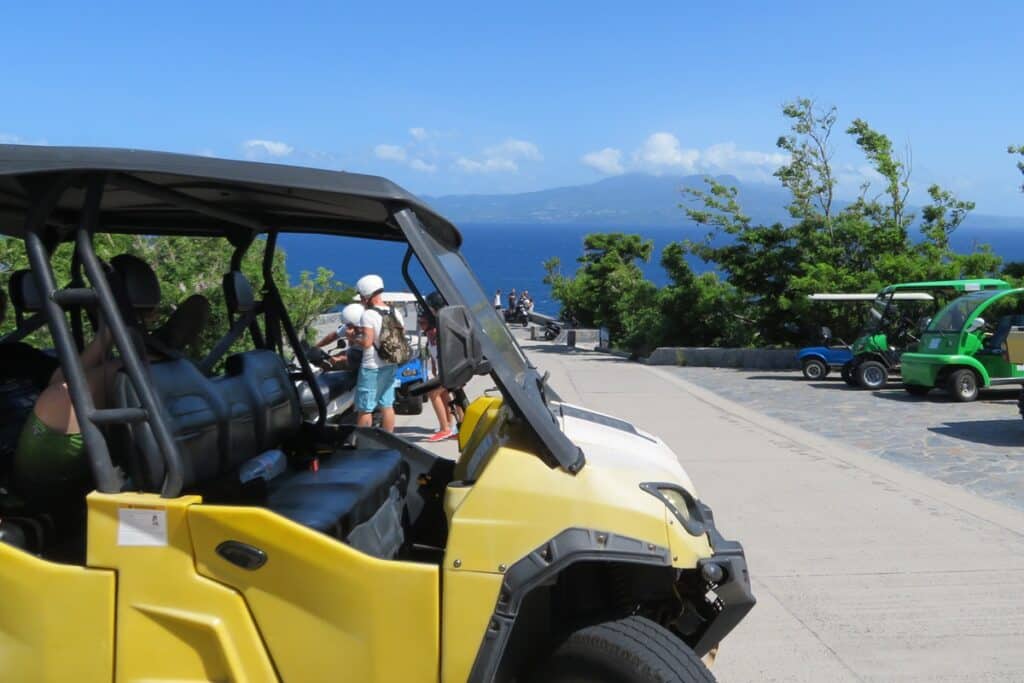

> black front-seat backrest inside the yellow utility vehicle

[{"left": 114, "top": 350, "right": 302, "bottom": 490}]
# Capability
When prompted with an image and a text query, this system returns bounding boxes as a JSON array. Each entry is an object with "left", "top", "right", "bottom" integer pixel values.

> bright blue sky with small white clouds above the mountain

[{"left": 6, "top": 0, "right": 1024, "bottom": 215}]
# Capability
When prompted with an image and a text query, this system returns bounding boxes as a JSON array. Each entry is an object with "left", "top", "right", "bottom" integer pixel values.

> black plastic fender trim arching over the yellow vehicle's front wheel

[{"left": 468, "top": 527, "right": 672, "bottom": 683}]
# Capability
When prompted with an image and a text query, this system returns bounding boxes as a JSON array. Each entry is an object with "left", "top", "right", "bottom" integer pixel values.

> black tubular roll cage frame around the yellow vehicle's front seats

[{"left": 16, "top": 172, "right": 327, "bottom": 498}]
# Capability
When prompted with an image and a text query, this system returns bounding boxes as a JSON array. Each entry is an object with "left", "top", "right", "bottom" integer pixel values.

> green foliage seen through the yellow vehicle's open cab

[{"left": 0, "top": 233, "right": 354, "bottom": 357}]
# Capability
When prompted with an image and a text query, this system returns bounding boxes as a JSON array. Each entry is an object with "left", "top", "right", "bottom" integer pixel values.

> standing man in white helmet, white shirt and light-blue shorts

[{"left": 355, "top": 274, "right": 402, "bottom": 432}]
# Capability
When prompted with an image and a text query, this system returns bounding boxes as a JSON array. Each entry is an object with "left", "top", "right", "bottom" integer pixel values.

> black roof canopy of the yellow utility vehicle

[{"left": 0, "top": 144, "right": 462, "bottom": 247}]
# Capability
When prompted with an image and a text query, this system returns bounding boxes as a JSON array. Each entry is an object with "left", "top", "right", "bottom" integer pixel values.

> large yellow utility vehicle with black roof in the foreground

[{"left": 0, "top": 145, "right": 755, "bottom": 683}]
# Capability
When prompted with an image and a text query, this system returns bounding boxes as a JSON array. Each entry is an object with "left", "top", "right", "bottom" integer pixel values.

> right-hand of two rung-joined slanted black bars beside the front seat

[{"left": 75, "top": 179, "right": 184, "bottom": 498}]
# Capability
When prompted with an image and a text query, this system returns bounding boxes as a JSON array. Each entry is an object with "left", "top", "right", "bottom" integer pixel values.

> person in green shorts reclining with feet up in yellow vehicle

[{"left": 10, "top": 295, "right": 209, "bottom": 504}]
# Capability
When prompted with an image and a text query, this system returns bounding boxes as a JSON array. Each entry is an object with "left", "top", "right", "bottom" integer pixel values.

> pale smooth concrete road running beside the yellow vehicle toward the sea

[{"left": 499, "top": 343, "right": 1024, "bottom": 682}]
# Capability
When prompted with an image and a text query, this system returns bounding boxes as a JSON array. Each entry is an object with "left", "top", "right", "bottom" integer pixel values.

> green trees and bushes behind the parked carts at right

[{"left": 546, "top": 99, "right": 1007, "bottom": 352}]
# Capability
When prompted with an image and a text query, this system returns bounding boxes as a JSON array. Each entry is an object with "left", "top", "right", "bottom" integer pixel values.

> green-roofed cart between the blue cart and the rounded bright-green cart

[{"left": 847, "top": 279, "right": 1010, "bottom": 390}]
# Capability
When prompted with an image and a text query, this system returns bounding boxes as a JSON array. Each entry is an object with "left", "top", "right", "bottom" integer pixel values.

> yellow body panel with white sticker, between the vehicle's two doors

[{"left": 86, "top": 494, "right": 278, "bottom": 683}]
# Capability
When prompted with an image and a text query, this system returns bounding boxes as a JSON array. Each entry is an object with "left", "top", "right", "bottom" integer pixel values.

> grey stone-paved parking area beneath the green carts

[{"left": 668, "top": 368, "right": 1024, "bottom": 510}]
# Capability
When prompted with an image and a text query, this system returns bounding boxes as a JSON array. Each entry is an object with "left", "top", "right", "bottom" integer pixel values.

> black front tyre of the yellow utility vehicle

[{"left": 530, "top": 616, "right": 715, "bottom": 683}]
